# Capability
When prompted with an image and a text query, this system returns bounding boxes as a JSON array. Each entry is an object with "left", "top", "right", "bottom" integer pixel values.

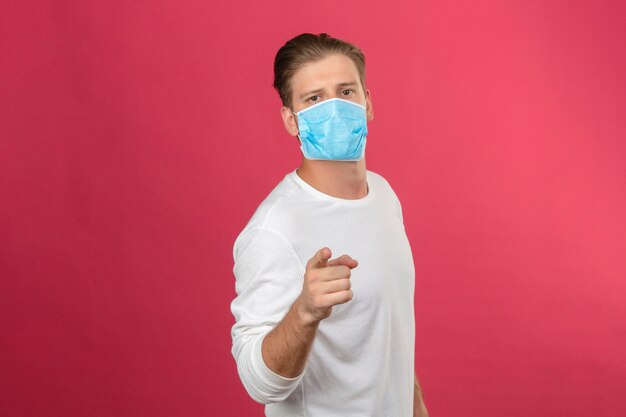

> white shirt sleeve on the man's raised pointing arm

[{"left": 231, "top": 228, "right": 305, "bottom": 404}]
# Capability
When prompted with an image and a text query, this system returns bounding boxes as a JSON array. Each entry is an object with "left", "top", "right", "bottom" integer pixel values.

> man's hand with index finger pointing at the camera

[{"left": 298, "top": 248, "right": 358, "bottom": 324}]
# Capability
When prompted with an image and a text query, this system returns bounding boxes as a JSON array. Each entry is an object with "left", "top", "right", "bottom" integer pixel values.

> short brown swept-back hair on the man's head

[{"left": 274, "top": 33, "right": 365, "bottom": 107}]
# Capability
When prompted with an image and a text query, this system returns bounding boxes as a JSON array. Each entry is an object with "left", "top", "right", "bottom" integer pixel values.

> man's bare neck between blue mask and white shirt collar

[{"left": 296, "top": 158, "right": 368, "bottom": 200}]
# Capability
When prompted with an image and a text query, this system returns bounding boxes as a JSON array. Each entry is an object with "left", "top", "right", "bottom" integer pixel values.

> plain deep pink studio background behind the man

[{"left": 0, "top": 0, "right": 626, "bottom": 417}]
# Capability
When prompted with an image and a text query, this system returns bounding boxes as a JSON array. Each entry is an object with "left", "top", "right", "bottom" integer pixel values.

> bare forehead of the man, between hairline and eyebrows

[{"left": 291, "top": 54, "right": 359, "bottom": 96}]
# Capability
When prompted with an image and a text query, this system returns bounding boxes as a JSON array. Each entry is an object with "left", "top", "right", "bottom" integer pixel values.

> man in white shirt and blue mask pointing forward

[{"left": 231, "top": 34, "right": 428, "bottom": 417}]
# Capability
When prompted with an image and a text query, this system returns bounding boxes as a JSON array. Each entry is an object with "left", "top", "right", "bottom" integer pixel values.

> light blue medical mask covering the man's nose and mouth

[{"left": 294, "top": 98, "right": 367, "bottom": 161}]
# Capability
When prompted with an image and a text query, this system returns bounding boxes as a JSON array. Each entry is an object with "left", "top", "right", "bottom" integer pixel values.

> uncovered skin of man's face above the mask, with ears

[{"left": 281, "top": 54, "right": 374, "bottom": 136}]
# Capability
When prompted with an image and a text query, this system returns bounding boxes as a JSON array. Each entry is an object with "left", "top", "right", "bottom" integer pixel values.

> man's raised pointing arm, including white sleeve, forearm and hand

[{"left": 231, "top": 234, "right": 357, "bottom": 404}]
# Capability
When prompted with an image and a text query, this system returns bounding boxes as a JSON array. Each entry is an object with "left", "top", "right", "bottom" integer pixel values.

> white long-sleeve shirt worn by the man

[{"left": 231, "top": 171, "right": 415, "bottom": 417}]
